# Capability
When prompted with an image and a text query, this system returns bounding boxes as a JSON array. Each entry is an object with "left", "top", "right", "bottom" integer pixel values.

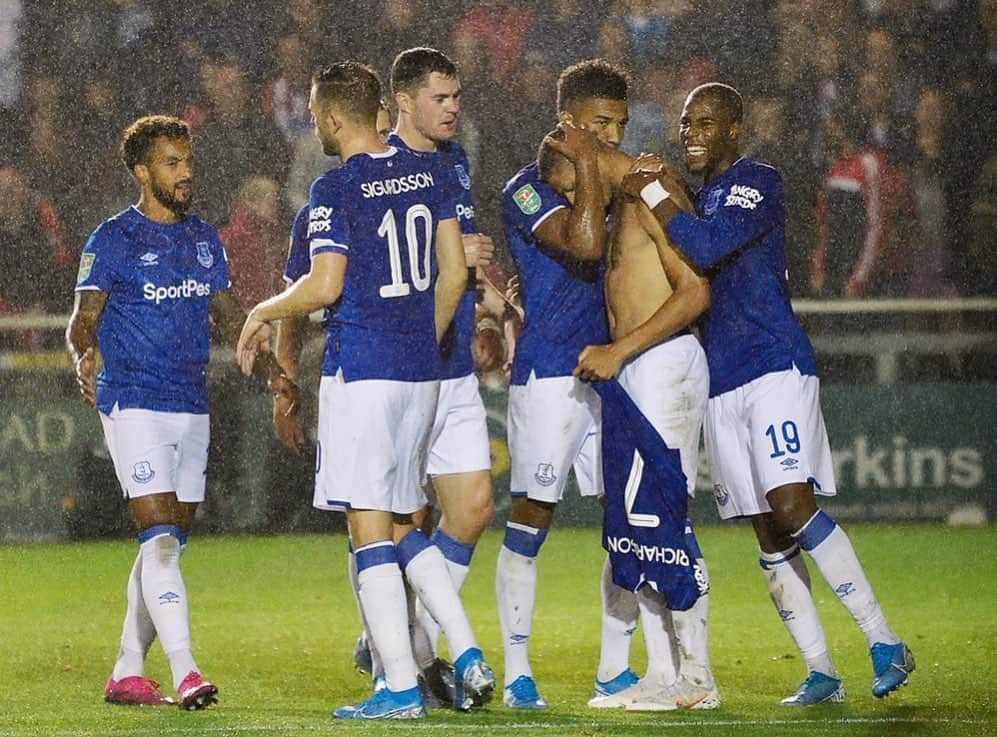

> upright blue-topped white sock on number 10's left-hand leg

[{"left": 356, "top": 541, "right": 418, "bottom": 691}]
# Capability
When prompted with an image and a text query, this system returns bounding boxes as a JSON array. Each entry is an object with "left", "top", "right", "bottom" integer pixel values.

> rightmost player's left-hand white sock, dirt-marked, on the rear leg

[{"left": 758, "top": 545, "right": 836, "bottom": 676}]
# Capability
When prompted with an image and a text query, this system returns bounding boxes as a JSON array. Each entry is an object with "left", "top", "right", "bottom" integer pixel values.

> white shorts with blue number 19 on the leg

[{"left": 705, "top": 366, "right": 836, "bottom": 519}]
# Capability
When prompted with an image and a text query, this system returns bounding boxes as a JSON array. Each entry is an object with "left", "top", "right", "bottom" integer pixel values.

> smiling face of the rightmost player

[{"left": 679, "top": 94, "right": 741, "bottom": 181}]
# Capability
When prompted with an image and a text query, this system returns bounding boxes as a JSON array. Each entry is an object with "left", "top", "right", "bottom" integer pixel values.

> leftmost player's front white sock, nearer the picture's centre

[{"left": 140, "top": 530, "right": 197, "bottom": 688}]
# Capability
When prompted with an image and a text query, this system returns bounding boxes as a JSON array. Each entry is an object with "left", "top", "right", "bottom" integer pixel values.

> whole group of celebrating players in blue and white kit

[{"left": 67, "top": 48, "right": 914, "bottom": 719}]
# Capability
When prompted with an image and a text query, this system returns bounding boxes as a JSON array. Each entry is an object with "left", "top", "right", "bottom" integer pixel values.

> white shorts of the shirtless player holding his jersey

[{"left": 619, "top": 334, "right": 710, "bottom": 496}]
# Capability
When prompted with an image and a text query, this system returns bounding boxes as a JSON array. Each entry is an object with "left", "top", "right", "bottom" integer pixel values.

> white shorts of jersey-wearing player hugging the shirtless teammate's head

[{"left": 509, "top": 373, "right": 604, "bottom": 503}]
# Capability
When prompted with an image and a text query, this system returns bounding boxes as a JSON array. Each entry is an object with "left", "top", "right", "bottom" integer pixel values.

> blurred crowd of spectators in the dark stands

[{"left": 0, "top": 0, "right": 997, "bottom": 340}]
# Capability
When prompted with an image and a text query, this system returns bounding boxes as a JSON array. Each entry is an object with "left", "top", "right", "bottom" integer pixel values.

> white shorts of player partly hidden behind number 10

[{"left": 427, "top": 374, "right": 492, "bottom": 476}]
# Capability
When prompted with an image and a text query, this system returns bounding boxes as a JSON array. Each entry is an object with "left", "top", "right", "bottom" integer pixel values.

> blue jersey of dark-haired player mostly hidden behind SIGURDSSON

[{"left": 388, "top": 133, "right": 477, "bottom": 379}]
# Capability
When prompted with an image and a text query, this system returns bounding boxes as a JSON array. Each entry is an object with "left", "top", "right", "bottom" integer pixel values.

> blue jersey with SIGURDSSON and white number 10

[{"left": 308, "top": 147, "right": 456, "bottom": 381}]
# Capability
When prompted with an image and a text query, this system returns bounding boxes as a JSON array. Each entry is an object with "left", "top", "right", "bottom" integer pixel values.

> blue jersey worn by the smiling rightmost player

[{"left": 668, "top": 159, "right": 817, "bottom": 397}]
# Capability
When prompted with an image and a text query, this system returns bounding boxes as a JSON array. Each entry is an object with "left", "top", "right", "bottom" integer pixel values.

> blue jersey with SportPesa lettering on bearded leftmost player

[{"left": 76, "top": 207, "right": 230, "bottom": 414}]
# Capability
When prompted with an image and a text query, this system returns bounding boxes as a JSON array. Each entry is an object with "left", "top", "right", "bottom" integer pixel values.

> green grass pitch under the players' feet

[{"left": 0, "top": 525, "right": 997, "bottom": 737}]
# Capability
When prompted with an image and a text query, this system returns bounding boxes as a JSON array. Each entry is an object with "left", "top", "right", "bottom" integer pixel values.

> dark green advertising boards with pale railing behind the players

[{"left": 0, "top": 300, "right": 997, "bottom": 541}]
